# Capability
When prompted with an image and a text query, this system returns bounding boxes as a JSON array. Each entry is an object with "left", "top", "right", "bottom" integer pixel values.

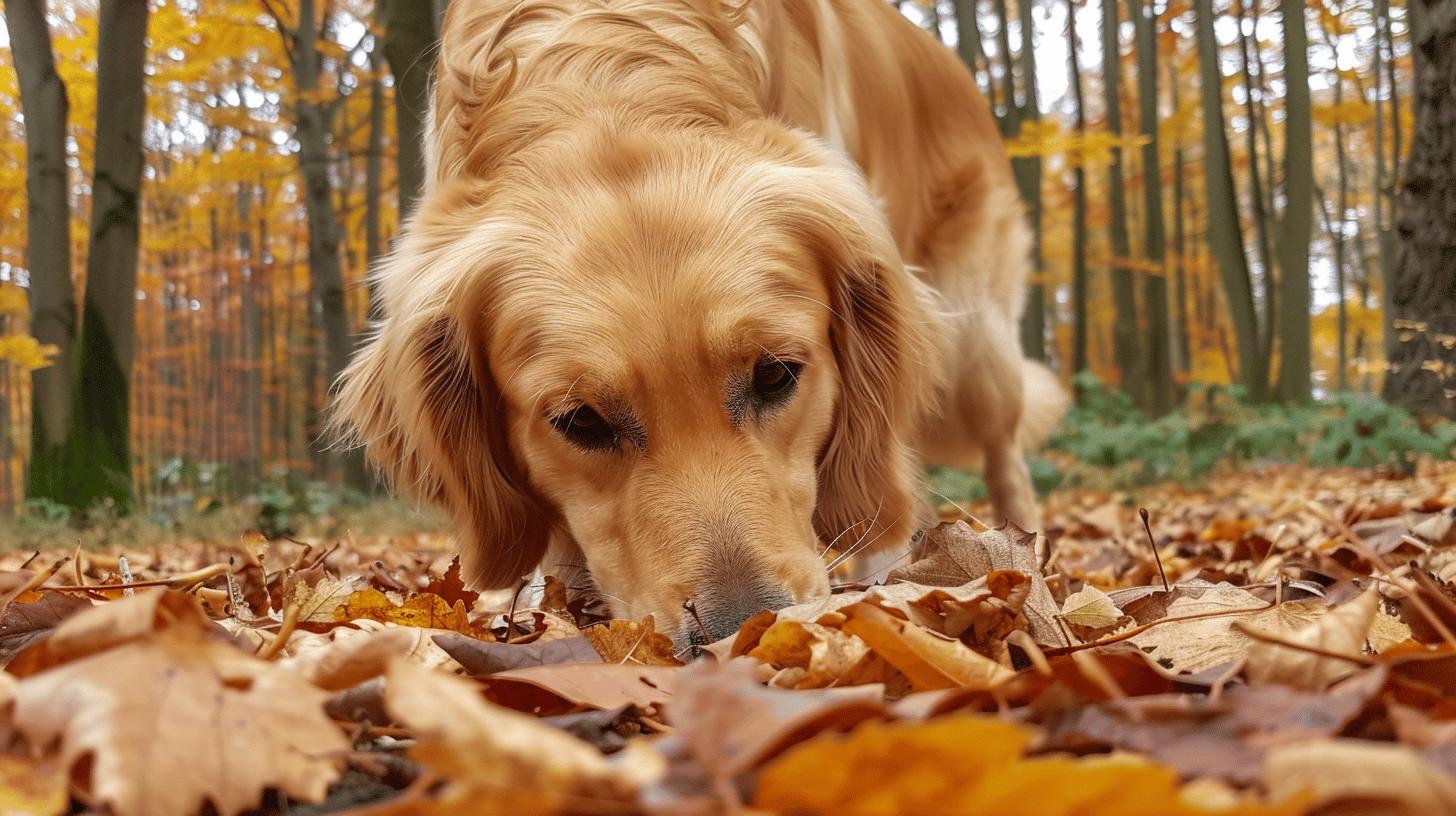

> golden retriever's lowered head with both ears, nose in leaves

[{"left": 336, "top": 125, "right": 933, "bottom": 643}]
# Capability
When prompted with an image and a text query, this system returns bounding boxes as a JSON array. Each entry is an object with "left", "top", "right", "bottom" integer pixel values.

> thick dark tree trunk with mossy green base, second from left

[{"left": 52, "top": 0, "right": 147, "bottom": 513}]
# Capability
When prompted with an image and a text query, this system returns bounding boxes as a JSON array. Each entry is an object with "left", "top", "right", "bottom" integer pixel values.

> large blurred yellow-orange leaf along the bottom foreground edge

[{"left": 753, "top": 717, "right": 1303, "bottom": 816}]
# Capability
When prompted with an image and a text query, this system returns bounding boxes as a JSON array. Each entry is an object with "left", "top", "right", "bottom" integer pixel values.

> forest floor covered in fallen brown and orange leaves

[{"left": 0, "top": 462, "right": 1456, "bottom": 816}]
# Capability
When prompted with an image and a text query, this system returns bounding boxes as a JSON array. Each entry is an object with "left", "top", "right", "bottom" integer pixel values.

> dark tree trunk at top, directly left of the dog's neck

[{"left": 379, "top": 0, "right": 438, "bottom": 220}]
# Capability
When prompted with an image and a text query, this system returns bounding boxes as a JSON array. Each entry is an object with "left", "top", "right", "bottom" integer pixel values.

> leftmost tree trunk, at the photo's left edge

[{"left": 4, "top": 0, "right": 76, "bottom": 498}]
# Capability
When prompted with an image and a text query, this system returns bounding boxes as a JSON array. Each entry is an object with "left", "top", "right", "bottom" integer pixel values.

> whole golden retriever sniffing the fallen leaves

[{"left": 333, "top": 0, "right": 1066, "bottom": 644}]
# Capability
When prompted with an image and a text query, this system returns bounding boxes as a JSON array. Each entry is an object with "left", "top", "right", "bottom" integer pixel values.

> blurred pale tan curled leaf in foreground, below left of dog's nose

[{"left": 381, "top": 660, "right": 660, "bottom": 816}]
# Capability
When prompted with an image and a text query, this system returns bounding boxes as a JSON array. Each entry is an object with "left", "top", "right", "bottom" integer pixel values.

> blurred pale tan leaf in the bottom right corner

[{"left": 1264, "top": 739, "right": 1456, "bottom": 816}]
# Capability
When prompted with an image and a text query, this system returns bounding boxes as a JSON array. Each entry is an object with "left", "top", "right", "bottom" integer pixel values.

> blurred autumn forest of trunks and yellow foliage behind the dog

[{"left": 0, "top": 0, "right": 1456, "bottom": 516}]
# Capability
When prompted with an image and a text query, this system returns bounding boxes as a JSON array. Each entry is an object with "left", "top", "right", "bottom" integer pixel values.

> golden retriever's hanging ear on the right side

[{"left": 780, "top": 169, "right": 941, "bottom": 556}]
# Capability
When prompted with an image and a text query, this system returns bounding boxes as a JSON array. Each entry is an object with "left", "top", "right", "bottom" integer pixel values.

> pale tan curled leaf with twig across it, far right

[{"left": 1235, "top": 589, "right": 1380, "bottom": 691}]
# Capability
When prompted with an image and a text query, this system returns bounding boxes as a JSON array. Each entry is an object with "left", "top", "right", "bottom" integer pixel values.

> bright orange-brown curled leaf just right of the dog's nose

[{"left": 842, "top": 603, "right": 1015, "bottom": 691}]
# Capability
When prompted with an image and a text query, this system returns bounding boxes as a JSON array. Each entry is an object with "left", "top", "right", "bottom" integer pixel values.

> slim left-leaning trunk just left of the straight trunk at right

[{"left": 1194, "top": 0, "right": 1263, "bottom": 401}]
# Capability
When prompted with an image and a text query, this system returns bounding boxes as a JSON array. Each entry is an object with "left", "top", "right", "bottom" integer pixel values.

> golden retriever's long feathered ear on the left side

[{"left": 331, "top": 187, "right": 549, "bottom": 589}]
